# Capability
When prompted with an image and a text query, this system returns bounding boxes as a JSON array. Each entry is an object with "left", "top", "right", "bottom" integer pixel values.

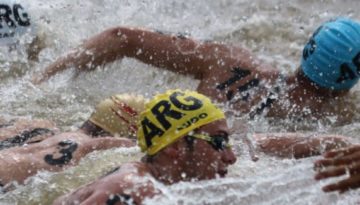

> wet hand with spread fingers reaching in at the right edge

[{"left": 314, "top": 145, "right": 360, "bottom": 193}]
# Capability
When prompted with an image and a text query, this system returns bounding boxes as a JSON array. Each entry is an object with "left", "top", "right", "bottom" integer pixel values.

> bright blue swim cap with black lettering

[{"left": 301, "top": 17, "right": 360, "bottom": 90}]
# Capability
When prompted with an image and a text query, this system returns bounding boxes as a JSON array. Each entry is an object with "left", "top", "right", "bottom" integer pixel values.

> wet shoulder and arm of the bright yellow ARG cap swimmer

[{"left": 53, "top": 165, "right": 161, "bottom": 205}]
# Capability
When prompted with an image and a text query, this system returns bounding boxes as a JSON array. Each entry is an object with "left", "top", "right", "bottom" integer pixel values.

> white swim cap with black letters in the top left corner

[{"left": 0, "top": 0, "right": 33, "bottom": 46}]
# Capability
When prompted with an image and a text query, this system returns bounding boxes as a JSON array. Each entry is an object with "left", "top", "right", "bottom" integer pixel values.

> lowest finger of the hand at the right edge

[{"left": 322, "top": 175, "right": 360, "bottom": 193}]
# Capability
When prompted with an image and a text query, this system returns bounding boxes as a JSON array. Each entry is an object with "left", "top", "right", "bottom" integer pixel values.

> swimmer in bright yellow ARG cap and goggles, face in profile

[{"left": 53, "top": 90, "right": 352, "bottom": 205}]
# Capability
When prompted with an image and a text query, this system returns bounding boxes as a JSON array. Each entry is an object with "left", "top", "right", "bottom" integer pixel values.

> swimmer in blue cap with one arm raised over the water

[{"left": 33, "top": 17, "right": 360, "bottom": 122}]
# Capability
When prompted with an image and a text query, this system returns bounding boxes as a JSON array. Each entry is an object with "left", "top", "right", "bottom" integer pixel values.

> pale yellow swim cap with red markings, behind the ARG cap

[{"left": 89, "top": 94, "right": 146, "bottom": 137}]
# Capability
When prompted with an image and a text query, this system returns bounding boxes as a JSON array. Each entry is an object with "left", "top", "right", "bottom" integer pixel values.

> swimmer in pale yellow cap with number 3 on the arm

[{"left": 0, "top": 94, "right": 145, "bottom": 185}]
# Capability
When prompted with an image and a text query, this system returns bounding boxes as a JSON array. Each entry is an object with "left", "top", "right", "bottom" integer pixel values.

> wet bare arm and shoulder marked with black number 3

[{"left": 0, "top": 132, "right": 134, "bottom": 184}]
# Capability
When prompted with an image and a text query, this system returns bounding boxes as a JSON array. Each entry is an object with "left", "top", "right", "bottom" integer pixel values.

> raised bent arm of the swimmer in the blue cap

[{"left": 36, "top": 27, "right": 257, "bottom": 83}]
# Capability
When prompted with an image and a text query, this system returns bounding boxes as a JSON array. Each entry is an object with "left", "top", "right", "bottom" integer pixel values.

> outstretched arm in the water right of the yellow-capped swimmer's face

[{"left": 254, "top": 133, "right": 350, "bottom": 158}]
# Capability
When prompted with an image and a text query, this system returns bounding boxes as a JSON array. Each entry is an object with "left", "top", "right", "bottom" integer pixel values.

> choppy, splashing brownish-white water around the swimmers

[{"left": 0, "top": 0, "right": 360, "bottom": 205}]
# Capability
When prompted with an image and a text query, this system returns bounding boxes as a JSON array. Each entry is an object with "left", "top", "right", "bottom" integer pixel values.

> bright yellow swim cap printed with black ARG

[{"left": 138, "top": 90, "right": 225, "bottom": 155}]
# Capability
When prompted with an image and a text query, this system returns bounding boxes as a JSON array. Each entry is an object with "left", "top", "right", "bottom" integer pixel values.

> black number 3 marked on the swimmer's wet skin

[{"left": 44, "top": 140, "right": 77, "bottom": 166}]
